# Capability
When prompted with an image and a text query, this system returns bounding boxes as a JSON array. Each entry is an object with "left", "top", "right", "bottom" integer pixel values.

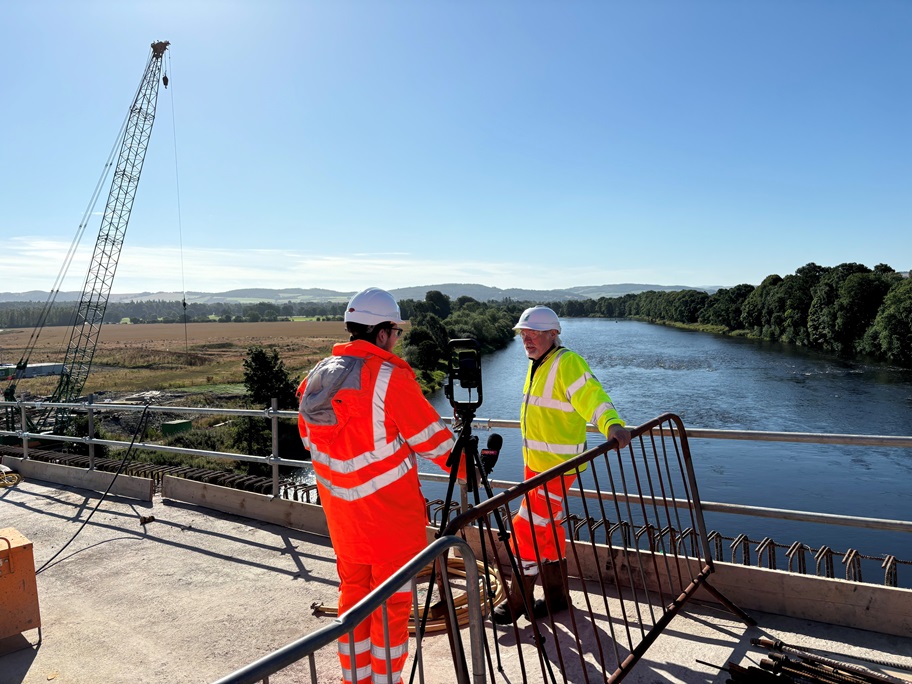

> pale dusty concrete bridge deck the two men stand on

[{"left": 0, "top": 481, "right": 912, "bottom": 684}]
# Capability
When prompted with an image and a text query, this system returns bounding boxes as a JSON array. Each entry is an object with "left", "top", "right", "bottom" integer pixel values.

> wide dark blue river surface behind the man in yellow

[{"left": 422, "top": 319, "right": 912, "bottom": 568}]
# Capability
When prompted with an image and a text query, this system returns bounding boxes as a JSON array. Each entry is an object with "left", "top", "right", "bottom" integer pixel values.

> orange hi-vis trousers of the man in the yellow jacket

[{"left": 513, "top": 466, "right": 576, "bottom": 575}]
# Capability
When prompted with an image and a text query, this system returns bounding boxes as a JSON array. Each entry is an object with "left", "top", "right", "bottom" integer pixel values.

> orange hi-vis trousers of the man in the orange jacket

[{"left": 336, "top": 558, "right": 412, "bottom": 684}]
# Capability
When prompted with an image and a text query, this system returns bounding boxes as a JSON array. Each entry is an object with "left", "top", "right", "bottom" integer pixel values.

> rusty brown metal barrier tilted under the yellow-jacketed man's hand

[{"left": 442, "top": 414, "right": 756, "bottom": 682}]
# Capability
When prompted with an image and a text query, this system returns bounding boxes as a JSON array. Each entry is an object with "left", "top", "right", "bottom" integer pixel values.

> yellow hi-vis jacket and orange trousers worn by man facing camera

[{"left": 513, "top": 347, "right": 624, "bottom": 575}]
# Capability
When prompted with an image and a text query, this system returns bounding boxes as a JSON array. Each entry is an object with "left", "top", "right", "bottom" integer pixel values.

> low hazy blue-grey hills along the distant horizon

[{"left": 0, "top": 283, "right": 719, "bottom": 304}]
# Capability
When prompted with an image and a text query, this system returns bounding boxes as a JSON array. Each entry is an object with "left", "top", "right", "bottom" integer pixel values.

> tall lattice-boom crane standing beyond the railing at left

[{"left": 4, "top": 40, "right": 170, "bottom": 431}]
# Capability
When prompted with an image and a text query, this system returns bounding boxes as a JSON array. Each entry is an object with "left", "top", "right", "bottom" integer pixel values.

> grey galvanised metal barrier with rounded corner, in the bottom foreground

[{"left": 215, "top": 536, "right": 488, "bottom": 684}]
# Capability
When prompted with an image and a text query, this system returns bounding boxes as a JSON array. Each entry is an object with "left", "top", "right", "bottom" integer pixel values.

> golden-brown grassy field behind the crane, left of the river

[{"left": 0, "top": 321, "right": 348, "bottom": 396}]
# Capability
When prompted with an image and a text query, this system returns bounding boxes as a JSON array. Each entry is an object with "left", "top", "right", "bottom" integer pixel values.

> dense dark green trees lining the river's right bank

[{"left": 532, "top": 263, "right": 912, "bottom": 368}]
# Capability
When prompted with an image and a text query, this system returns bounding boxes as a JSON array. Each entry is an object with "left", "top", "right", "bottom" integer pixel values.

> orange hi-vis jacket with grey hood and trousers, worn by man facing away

[{"left": 298, "top": 340, "right": 465, "bottom": 684}]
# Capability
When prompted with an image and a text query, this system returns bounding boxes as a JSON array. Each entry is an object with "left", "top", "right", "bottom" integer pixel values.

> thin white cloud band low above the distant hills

[{"left": 0, "top": 238, "right": 712, "bottom": 294}]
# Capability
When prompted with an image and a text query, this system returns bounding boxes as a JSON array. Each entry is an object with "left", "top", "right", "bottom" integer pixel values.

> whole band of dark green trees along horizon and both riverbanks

[{"left": 7, "top": 263, "right": 912, "bottom": 368}]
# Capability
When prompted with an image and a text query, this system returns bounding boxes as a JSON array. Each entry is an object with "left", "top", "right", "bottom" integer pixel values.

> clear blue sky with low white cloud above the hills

[{"left": 0, "top": 0, "right": 912, "bottom": 293}]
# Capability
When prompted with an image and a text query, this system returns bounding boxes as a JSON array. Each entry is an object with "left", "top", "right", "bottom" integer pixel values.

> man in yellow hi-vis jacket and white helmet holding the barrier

[{"left": 493, "top": 306, "right": 630, "bottom": 624}]
